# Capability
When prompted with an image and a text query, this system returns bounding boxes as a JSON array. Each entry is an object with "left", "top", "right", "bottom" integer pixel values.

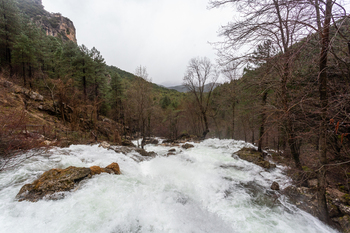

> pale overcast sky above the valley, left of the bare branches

[{"left": 42, "top": 0, "right": 233, "bottom": 86}]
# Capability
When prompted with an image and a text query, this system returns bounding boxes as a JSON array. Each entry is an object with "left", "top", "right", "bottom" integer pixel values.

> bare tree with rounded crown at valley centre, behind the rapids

[{"left": 183, "top": 57, "right": 219, "bottom": 139}]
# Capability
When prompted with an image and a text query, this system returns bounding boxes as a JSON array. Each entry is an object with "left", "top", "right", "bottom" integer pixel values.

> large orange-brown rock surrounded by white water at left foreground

[{"left": 16, "top": 163, "right": 121, "bottom": 202}]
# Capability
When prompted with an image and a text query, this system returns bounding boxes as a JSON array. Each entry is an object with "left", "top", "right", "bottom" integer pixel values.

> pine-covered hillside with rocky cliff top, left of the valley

[{"left": 0, "top": 0, "right": 186, "bottom": 144}]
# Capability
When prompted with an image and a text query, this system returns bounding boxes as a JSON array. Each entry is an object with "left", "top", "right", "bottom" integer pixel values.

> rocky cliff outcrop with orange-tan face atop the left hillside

[{"left": 18, "top": 0, "right": 77, "bottom": 43}]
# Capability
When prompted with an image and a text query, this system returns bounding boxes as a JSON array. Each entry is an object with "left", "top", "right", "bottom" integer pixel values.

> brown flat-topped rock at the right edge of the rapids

[{"left": 235, "top": 148, "right": 276, "bottom": 169}]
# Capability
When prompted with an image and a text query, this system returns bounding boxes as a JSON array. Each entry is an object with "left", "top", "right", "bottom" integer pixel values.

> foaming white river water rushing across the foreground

[{"left": 0, "top": 139, "right": 336, "bottom": 233}]
